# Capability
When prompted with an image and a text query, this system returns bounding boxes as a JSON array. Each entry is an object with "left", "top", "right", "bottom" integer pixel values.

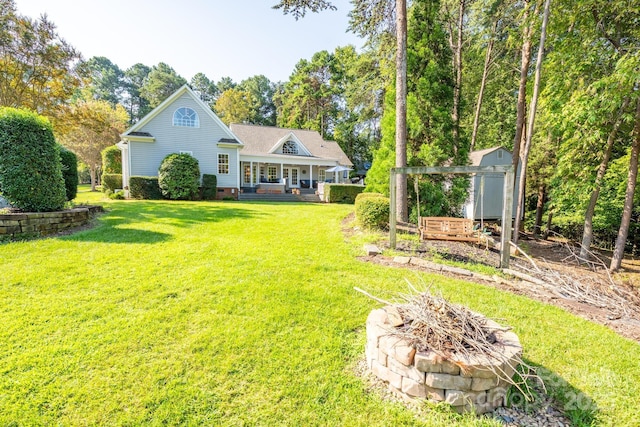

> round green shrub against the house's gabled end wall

[{"left": 158, "top": 153, "right": 200, "bottom": 200}]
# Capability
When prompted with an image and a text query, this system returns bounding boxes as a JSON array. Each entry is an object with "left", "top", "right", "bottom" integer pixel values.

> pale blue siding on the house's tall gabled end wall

[{"left": 129, "top": 93, "right": 239, "bottom": 188}]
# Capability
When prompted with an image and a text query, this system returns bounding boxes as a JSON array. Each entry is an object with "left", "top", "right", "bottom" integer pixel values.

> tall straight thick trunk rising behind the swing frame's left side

[{"left": 396, "top": 0, "right": 409, "bottom": 222}]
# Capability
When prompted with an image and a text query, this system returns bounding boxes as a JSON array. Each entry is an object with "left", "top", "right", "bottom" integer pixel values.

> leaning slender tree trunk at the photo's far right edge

[{"left": 609, "top": 99, "right": 640, "bottom": 271}]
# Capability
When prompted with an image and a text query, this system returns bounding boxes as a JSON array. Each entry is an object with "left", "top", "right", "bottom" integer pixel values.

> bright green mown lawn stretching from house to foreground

[{"left": 0, "top": 191, "right": 640, "bottom": 426}]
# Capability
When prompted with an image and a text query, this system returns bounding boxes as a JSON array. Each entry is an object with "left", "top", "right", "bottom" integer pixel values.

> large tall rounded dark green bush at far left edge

[{"left": 0, "top": 108, "right": 66, "bottom": 212}]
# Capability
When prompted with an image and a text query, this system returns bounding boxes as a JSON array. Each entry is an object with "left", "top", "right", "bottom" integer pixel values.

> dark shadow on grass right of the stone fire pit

[{"left": 507, "top": 359, "right": 596, "bottom": 427}]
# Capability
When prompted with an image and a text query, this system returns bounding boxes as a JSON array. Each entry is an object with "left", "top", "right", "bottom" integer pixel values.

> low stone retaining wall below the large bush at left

[{"left": 0, "top": 206, "right": 103, "bottom": 237}]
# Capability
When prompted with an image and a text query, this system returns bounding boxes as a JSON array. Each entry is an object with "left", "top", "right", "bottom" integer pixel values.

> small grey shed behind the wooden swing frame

[{"left": 463, "top": 147, "right": 520, "bottom": 221}]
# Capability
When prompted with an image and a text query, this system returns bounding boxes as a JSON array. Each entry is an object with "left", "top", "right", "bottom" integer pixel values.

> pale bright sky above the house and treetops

[{"left": 15, "top": 0, "right": 363, "bottom": 82}]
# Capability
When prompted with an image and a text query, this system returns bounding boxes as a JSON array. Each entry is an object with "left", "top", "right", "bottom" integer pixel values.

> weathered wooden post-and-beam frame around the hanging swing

[{"left": 389, "top": 165, "right": 515, "bottom": 268}]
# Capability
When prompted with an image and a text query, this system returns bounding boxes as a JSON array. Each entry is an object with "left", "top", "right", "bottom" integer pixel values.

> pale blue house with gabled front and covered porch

[{"left": 117, "top": 85, "right": 352, "bottom": 198}]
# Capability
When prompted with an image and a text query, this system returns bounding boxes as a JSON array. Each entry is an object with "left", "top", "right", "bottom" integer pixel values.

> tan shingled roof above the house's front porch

[{"left": 230, "top": 123, "right": 353, "bottom": 166}]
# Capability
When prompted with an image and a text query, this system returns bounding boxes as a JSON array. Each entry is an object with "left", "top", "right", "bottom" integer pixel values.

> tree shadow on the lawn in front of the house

[{"left": 63, "top": 200, "right": 264, "bottom": 244}]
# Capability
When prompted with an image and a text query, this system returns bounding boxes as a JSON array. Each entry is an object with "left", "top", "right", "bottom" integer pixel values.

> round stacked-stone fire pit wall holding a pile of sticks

[{"left": 366, "top": 308, "right": 522, "bottom": 414}]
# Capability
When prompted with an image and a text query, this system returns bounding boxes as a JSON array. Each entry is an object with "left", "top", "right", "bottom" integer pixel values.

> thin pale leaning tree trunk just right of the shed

[{"left": 513, "top": 0, "right": 551, "bottom": 244}]
